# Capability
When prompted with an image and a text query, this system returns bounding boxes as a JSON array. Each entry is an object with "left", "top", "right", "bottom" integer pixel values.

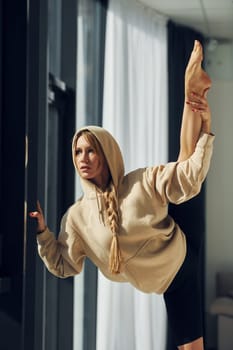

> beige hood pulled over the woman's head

[{"left": 72, "top": 125, "right": 125, "bottom": 188}]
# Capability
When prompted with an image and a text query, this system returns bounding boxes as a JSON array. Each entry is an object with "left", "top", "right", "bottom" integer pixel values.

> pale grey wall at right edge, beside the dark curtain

[{"left": 206, "top": 43, "right": 233, "bottom": 347}]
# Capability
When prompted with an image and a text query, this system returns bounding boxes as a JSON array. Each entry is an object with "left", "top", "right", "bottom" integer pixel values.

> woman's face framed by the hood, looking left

[{"left": 75, "top": 135, "right": 109, "bottom": 187}]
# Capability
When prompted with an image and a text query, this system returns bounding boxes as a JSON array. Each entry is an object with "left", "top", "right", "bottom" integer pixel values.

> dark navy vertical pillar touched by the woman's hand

[{"left": 22, "top": 0, "right": 48, "bottom": 350}]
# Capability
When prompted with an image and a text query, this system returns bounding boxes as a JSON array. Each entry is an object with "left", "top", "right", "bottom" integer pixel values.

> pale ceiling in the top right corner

[{"left": 138, "top": 0, "right": 233, "bottom": 40}]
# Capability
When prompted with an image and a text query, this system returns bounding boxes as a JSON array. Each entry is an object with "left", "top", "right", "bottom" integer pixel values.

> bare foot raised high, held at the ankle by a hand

[{"left": 185, "top": 40, "right": 211, "bottom": 97}]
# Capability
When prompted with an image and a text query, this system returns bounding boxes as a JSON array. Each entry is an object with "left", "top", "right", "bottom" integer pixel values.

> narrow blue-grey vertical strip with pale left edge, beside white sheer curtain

[{"left": 73, "top": 0, "right": 108, "bottom": 350}]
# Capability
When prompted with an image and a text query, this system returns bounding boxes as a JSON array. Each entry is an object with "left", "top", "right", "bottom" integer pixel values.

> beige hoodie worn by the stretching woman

[{"left": 37, "top": 126, "right": 214, "bottom": 293}]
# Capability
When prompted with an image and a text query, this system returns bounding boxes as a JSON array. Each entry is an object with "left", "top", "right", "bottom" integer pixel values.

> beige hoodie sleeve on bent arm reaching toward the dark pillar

[{"left": 37, "top": 217, "right": 86, "bottom": 278}]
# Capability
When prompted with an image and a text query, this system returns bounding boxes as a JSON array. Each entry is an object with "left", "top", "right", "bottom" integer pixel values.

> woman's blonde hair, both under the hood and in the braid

[{"left": 74, "top": 129, "right": 122, "bottom": 274}]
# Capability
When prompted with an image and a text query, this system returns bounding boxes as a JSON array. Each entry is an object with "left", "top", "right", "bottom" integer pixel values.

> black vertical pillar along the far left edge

[{"left": 0, "top": 0, "right": 27, "bottom": 349}]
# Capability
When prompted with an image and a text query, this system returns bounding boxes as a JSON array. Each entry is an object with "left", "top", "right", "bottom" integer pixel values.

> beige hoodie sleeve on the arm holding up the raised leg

[{"left": 152, "top": 133, "right": 214, "bottom": 205}]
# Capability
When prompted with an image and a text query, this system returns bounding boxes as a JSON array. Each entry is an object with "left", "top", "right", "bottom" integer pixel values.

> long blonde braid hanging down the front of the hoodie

[{"left": 104, "top": 184, "right": 122, "bottom": 274}]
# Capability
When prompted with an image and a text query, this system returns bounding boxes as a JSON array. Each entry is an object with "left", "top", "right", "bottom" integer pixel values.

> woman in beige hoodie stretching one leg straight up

[{"left": 30, "top": 41, "right": 214, "bottom": 350}]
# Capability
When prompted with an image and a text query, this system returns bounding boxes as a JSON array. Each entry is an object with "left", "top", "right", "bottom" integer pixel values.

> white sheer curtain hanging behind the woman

[{"left": 97, "top": 0, "right": 168, "bottom": 350}]
